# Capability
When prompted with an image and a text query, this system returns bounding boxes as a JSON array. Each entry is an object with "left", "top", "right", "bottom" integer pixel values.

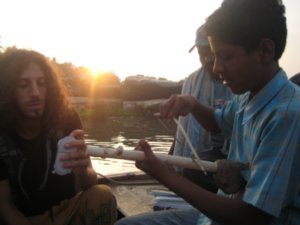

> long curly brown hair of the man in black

[{"left": 0, "top": 48, "right": 74, "bottom": 131}]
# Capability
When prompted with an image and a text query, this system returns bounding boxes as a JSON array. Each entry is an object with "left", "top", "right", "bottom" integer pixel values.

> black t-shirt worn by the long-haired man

[{"left": 0, "top": 112, "right": 82, "bottom": 216}]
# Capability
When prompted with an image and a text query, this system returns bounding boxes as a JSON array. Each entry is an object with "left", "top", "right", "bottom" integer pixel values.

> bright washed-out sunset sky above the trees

[{"left": 0, "top": 0, "right": 300, "bottom": 80}]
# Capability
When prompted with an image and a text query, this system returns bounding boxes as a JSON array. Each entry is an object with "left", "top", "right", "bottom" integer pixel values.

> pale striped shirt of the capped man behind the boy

[{"left": 174, "top": 68, "right": 233, "bottom": 162}]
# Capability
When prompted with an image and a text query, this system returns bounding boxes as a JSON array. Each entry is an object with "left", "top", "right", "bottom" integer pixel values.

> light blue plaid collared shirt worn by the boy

[{"left": 198, "top": 70, "right": 300, "bottom": 225}]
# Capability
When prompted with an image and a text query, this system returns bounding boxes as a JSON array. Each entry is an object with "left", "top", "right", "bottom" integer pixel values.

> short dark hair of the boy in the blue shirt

[{"left": 205, "top": 0, "right": 287, "bottom": 61}]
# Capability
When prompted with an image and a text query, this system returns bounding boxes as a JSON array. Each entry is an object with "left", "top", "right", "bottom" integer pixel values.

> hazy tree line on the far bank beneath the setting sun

[{"left": 0, "top": 45, "right": 182, "bottom": 100}]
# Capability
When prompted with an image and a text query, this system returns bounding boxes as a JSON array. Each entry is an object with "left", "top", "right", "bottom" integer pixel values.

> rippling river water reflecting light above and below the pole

[{"left": 83, "top": 116, "right": 176, "bottom": 175}]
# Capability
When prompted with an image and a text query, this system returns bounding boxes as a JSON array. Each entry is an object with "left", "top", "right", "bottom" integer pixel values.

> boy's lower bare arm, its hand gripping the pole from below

[{"left": 136, "top": 141, "right": 272, "bottom": 225}]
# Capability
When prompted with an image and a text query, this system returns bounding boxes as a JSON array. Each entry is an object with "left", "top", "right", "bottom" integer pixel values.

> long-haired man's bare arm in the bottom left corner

[{"left": 0, "top": 180, "right": 30, "bottom": 225}]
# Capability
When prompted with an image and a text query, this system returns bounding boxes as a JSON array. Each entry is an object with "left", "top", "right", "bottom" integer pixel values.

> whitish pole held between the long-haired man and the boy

[{"left": 86, "top": 145, "right": 217, "bottom": 172}]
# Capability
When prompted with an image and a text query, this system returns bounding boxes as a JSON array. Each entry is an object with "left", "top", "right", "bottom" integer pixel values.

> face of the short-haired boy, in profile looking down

[{"left": 209, "top": 37, "right": 264, "bottom": 95}]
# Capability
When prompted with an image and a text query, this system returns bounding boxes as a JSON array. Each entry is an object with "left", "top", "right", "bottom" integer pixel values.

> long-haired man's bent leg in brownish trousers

[{"left": 29, "top": 185, "right": 117, "bottom": 225}]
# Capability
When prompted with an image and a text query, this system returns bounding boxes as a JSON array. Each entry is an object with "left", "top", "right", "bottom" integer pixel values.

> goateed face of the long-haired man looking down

[{"left": 16, "top": 63, "right": 47, "bottom": 119}]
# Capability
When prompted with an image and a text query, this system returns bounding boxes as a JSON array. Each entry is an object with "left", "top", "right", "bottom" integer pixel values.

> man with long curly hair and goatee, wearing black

[{"left": 0, "top": 48, "right": 116, "bottom": 225}]
